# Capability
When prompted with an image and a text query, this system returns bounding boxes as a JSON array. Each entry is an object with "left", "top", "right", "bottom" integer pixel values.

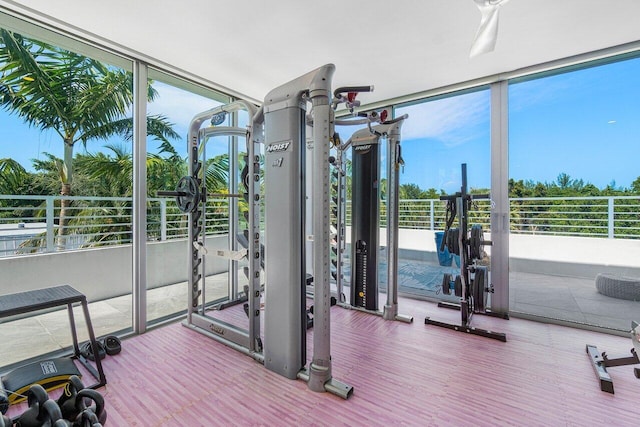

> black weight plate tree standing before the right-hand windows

[{"left": 424, "top": 163, "right": 509, "bottom": 342}]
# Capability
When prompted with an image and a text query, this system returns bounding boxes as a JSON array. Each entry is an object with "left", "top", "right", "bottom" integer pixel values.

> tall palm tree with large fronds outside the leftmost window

[{"left": 0, "top": 29, "right": 178, "bottom": 247}]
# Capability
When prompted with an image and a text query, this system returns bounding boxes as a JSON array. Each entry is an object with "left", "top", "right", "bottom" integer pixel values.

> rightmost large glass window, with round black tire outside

[{"left": 509, "top": 55, "right": 640, "bottom": 330}]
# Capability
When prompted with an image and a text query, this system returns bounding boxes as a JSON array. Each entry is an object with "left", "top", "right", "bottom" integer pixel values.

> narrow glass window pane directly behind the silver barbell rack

[{"left": 147, "top": 70, "right": 232, "bottom": 322}]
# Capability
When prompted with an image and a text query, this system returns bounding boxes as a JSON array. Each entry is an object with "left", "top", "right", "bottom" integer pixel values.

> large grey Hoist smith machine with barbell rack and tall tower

[{"left": 161, "top": 64, "right": 368, "bottom": 399}]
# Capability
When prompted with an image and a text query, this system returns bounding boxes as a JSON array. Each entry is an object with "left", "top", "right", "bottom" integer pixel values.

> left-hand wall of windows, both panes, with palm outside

[{"left": 0, "top": 9, "right": 234, "bottom": 372}]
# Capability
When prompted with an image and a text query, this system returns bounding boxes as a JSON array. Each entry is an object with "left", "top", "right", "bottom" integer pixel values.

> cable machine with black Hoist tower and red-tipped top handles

[{"left": 331, "top": 111, "right": 413, "bottom": 323}]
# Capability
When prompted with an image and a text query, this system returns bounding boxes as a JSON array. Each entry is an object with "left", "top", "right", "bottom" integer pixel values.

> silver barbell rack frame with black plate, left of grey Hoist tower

[{"left": 158, "top": 100, "right": 262, "bottom": 354}]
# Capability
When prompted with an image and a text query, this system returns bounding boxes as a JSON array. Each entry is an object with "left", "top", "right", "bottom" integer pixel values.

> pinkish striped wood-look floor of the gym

[{"left": 11, "top": 300, "right": 640, "bottom": 426}]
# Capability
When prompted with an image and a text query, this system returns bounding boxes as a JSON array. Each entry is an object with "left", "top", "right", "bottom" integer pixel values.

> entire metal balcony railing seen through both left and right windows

[{"left": 0, "top": 195, "right": 640, "bottom": 256}]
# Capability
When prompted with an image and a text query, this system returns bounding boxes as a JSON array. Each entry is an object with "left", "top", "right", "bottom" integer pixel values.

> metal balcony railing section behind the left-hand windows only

[{"left": 0, "top": 195, "right": 229, "bottom": 256}]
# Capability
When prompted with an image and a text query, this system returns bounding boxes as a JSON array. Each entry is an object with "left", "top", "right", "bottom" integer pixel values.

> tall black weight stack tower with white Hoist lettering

[{"left": 350, "top": 139, "right": 380, "bottom": 311}]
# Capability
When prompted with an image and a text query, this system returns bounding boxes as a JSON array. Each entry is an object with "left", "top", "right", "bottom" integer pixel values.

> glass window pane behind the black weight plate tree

[{"left": 395, "top": 88, "right": 491, "bottom": 300}]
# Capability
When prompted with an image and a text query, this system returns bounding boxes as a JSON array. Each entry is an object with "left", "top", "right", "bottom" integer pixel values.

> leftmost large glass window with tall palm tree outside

[{"left": 0, "top": 15, "right": 133, "bottom": 365}]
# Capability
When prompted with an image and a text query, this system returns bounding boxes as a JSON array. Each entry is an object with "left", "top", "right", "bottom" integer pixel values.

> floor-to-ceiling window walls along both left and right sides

[{"left": 0, "top": 4, "right": 640, "bottom": 374}]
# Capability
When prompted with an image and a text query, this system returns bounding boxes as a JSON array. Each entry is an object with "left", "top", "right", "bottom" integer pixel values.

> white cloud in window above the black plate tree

[{"left": 396, "top": 91, "right": 489, "bottom": 146}]
